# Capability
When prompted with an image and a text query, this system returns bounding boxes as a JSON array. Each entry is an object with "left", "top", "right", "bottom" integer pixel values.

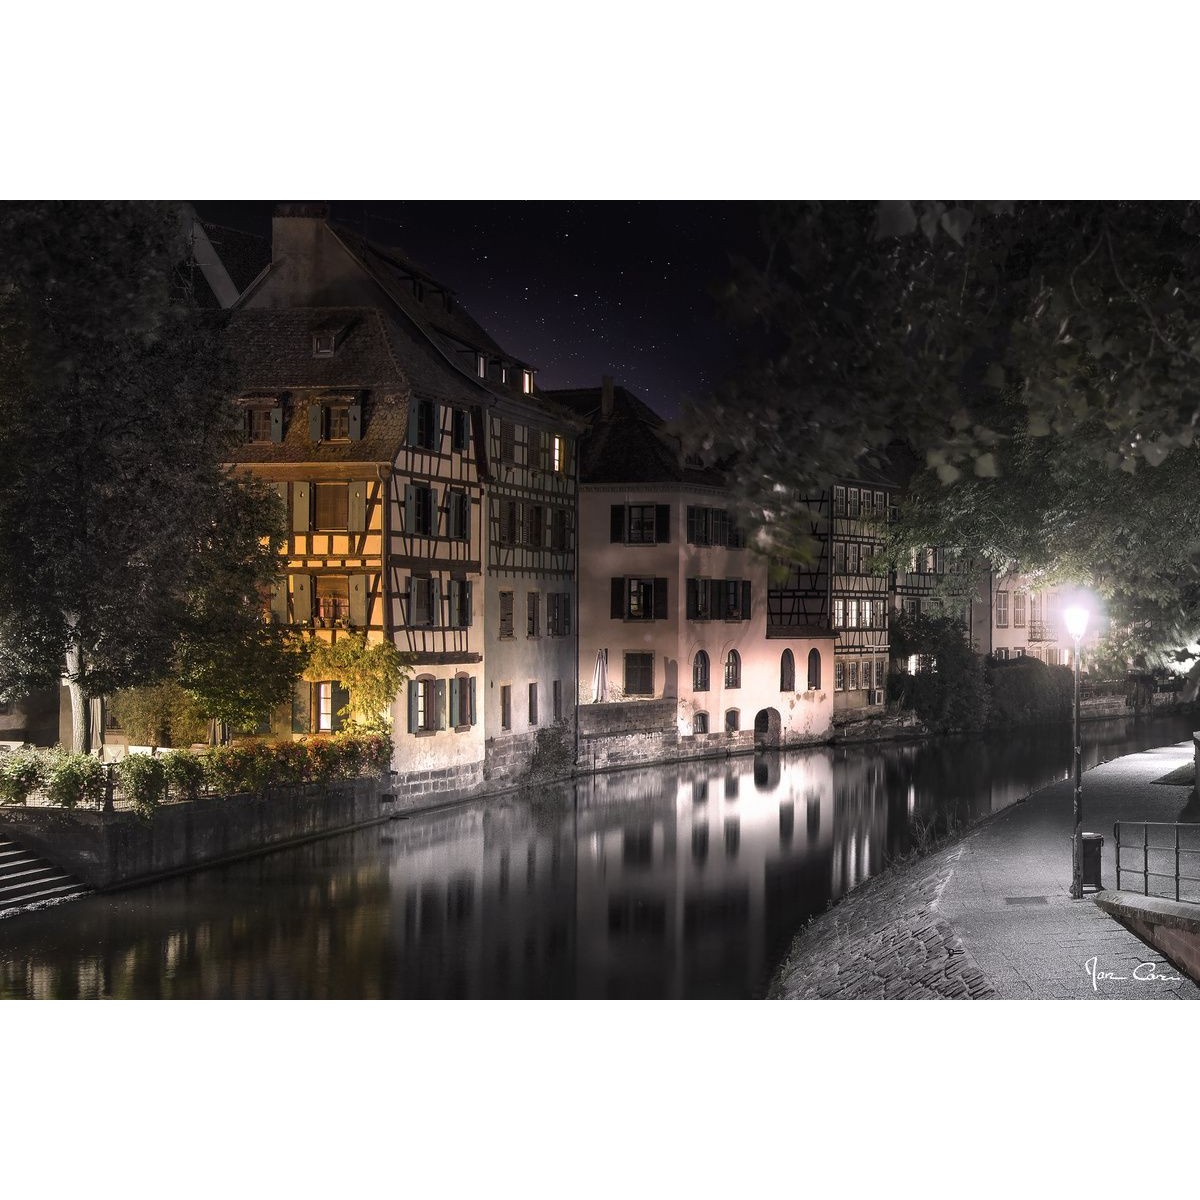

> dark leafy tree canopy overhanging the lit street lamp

[{"left": 683, "top": 202, "right": 1200, "bottom": 667}]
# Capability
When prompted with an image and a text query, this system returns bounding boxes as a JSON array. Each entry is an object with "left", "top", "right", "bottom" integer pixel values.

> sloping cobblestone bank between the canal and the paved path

[{"left": 770, "top": 846, "right": 996, "bottom": 1000}]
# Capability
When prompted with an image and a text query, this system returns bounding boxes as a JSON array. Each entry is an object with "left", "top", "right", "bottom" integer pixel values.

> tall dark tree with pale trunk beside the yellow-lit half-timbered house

[{"left": 0, "top": 203, "right": 300, "bottom": 749}]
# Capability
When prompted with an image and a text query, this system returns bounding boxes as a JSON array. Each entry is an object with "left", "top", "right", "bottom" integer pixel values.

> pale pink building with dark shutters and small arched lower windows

[{"left": 551, "top": 378, "right": 833, "bottom": 756}]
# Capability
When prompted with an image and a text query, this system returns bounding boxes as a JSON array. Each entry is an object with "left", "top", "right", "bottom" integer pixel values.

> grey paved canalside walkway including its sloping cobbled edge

[{"left": 772, "top": 742, "right": 1200, "bottom": 1000}]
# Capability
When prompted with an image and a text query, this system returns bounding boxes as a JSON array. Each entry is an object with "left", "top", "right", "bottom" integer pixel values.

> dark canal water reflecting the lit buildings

[{"left": 0, "top": 716, "right": 1193, "bottom": 998}]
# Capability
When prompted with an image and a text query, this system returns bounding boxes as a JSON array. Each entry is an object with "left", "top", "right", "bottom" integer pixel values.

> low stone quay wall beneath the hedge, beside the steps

[{"left": 0, "top": 779, "right": 395, "bottom": 889}]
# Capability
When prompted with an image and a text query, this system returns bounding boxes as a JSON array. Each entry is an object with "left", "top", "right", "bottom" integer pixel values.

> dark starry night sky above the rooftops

[{"left": 196, "top": 200, "right": 761, "bottom": 416}]
